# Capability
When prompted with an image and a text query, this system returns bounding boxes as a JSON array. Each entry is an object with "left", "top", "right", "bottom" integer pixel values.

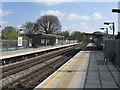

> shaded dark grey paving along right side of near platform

[{"left": 83, "top": 45, "right": 118, "bottom": 88}]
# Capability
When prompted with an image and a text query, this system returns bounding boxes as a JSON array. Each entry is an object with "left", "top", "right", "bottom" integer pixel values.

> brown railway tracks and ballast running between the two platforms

[{"left": 0, "top": 43, "right": 87, "bottom": 89}]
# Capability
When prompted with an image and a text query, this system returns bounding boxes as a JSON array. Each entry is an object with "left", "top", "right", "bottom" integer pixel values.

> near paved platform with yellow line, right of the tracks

[{"left": 34, "top": 43, "right": 119, "bottom": 90}]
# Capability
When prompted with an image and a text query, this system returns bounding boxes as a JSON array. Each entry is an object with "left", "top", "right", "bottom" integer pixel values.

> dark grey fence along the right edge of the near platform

[{"left": 103, "top": 39, "right": 120, "bottom": 68}]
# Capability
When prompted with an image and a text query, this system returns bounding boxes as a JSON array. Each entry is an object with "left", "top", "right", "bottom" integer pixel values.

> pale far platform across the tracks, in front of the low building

[{"left": 0, "top": 43, "right": 78, "bottom": 59}]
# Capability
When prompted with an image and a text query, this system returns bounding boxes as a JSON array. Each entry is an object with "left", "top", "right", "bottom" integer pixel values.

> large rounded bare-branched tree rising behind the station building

[{"left": 36, "top": 15, "right": 61, "bottom": 34}]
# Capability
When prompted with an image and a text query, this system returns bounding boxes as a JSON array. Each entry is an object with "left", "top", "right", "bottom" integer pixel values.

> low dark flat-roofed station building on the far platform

[{"left": 27, "top": 34, "right": 64, "bottom": 47}]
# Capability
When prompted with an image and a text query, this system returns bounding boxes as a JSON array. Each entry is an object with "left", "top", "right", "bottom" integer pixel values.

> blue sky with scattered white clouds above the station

[{"left": 0, "top": 1, "right": 118, "bottom": 34}]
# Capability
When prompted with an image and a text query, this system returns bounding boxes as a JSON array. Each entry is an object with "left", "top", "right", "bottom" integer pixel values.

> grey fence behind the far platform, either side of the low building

[{"left": 0, "top": 40, "right": 77, "bottom": 51}]
